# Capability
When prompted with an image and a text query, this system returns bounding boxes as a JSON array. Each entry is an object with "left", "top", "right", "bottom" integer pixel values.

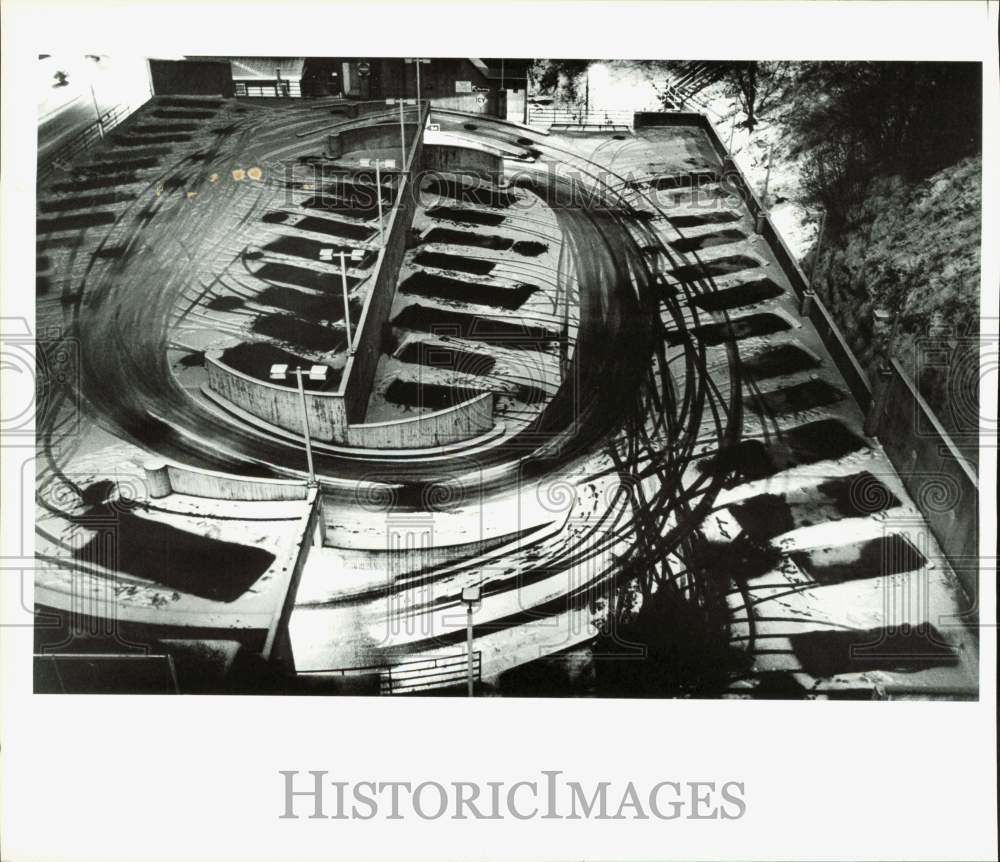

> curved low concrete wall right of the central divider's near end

[{"left": 347, "top": 392, "right": 493, "bottom": 449}]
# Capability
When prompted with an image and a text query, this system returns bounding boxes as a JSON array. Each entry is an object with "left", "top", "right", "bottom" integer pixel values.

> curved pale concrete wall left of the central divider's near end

[{"left": 205, "top": 351, "right": 347, "bottom": 443}]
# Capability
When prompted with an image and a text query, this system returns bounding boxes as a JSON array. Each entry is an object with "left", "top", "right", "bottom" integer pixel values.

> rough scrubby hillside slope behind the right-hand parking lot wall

[{"left": 805, "top": 156, "right": 982, "bottom": 462}]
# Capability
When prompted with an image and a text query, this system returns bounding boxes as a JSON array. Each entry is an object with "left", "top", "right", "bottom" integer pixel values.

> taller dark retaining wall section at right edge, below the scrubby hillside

[{"left": 872, "top": 359, "right": 979, "bottom": 598}]
